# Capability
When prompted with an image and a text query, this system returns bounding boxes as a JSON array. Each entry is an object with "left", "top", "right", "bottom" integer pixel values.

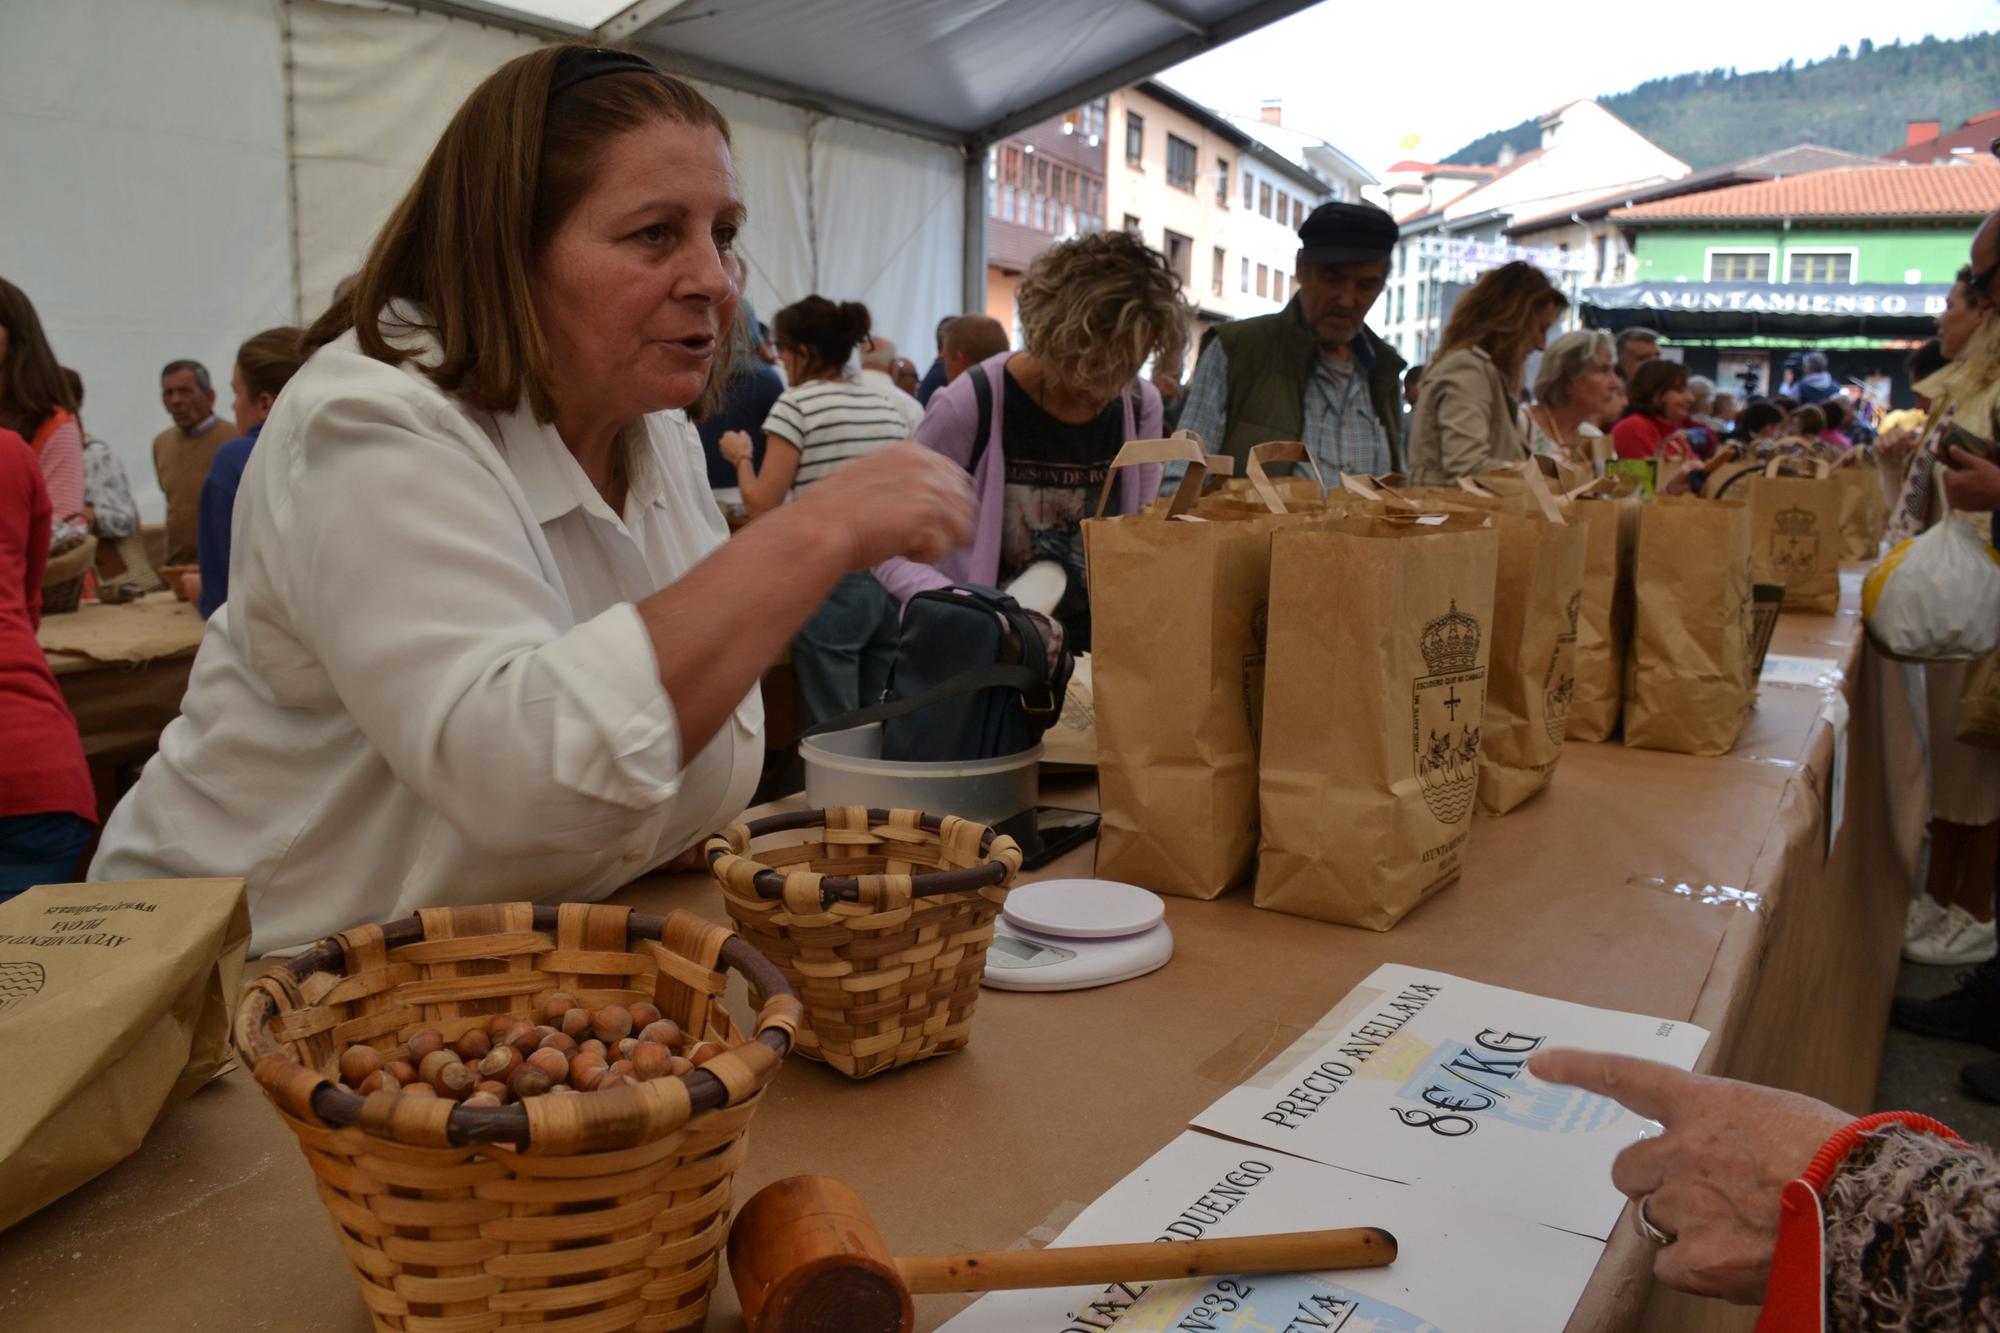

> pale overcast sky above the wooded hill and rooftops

[{"left": 1162, "top": 0, "right": 2000, "bottom": 170}]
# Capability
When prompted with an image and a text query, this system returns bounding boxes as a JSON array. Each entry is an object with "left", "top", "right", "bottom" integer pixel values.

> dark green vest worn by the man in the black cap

[{"left": 1208, "top": 296, "right": 1404, "bottom": 476}]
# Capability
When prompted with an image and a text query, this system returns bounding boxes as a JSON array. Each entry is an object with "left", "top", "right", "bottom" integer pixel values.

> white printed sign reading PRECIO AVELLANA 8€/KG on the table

[{"left": 1194, "top": 963, "right": 1708, "bottom": 1241}]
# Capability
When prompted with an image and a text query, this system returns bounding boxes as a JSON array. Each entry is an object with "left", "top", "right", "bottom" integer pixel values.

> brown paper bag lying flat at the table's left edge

[{"left": 0, "top": 879, "right": 250, "bottom": 1229}]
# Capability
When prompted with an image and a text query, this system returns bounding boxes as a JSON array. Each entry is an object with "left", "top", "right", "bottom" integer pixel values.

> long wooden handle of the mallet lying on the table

[{"left": 896, "top": 1227, "right": 1396, "bottom": 1295}]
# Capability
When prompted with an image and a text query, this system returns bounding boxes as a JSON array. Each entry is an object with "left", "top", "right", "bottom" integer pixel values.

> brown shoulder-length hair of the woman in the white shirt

[{"left": 304, "top": 46, "right": 748, "bottom": 422}]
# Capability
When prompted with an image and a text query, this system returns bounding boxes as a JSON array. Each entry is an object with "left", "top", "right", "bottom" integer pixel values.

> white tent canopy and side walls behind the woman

[{"left": 0, "top": 0, "right": 1310, "bottom": 516}]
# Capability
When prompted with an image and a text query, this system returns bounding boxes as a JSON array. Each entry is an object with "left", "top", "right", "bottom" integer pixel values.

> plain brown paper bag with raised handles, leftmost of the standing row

[{"left": 1084, "top": 440, "right": 1274, "bottom": 899}]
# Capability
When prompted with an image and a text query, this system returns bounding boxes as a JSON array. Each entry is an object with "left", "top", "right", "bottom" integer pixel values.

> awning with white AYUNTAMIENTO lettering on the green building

[{"left": 1582, "top": 282, "right": 1950, "bottom": 340}]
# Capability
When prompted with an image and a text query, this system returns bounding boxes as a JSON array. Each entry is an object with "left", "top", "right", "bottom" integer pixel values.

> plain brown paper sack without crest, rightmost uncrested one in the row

[{"left": 1624, "top": 496, "right": 1754, "bottom": 755}]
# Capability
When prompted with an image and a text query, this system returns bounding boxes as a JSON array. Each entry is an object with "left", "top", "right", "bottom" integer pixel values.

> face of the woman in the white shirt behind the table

[{"left": 534, "top": 120, "right": 744, "bottom": 420}]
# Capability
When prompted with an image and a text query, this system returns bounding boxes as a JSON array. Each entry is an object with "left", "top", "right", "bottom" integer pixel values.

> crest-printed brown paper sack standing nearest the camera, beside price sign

[{"left": 1256, "top": 512, "right": 1500, "bottom": 931}]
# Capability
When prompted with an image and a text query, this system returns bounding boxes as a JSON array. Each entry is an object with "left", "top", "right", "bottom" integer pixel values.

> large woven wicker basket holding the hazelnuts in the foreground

[{"left": 236, "top": 903, "right": 798, "bottom": 1333}]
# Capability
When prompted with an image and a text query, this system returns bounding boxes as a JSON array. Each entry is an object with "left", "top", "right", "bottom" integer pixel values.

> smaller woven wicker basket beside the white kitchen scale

[{"left": 706, "top": 807, "right": 1020, "bottom": 1079}]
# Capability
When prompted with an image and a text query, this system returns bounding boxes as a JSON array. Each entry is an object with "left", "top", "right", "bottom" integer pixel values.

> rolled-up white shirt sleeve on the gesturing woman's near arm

[{"left": 252, "top": 378, "right": 682, "bottom": 851}]
